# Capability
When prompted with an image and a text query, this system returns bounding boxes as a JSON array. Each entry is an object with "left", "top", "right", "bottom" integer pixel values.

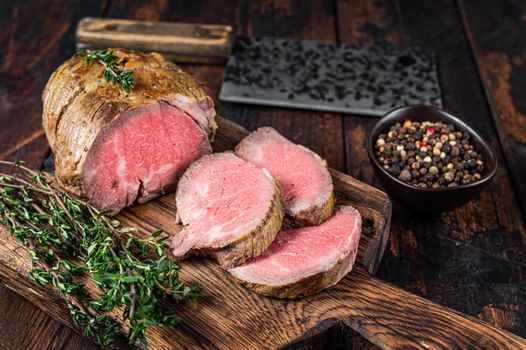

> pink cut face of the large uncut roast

[{"left": 82, "top": 102, "right": 212, "bottom": 213}]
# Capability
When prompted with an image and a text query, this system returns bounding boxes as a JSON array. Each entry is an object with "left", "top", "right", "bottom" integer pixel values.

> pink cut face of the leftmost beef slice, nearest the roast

[{"left": 172, "top": 152, "right": 280, "bottom": 257}]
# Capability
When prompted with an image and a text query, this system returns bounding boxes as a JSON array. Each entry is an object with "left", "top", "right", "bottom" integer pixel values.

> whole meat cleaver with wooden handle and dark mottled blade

[{"left": 77, "top": 18, "right": 442, "bottom": 116}]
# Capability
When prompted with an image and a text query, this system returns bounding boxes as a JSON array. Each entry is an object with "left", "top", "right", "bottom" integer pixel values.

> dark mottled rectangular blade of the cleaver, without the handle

[{"left": 219, "top": 37, "right": 442, "bottom": 116}]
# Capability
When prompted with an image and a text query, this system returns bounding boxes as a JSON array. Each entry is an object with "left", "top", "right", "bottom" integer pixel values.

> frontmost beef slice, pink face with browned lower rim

[{"left": 228, "top": 206, "right": 362, "bottom": 298}]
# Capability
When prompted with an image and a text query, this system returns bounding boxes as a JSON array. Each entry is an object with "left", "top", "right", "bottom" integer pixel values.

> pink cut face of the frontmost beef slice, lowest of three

[{"left": 229, "top": 207, "right": 361, "bottom": 286}]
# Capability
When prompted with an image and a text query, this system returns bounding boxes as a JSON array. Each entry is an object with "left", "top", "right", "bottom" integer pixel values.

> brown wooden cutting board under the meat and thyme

[{"left": 0, "top": 118, "right": 526, "bottom": 349}]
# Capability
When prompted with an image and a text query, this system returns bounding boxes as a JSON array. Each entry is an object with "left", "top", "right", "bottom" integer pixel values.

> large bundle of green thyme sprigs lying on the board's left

[{"left": 0, "top": 161, "right": 197, "bottom": 347}]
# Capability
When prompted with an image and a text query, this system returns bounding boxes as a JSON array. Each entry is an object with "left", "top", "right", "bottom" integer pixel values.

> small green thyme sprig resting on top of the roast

[{"left": 77, "top": 49, "right": 135, "bottom": 93}]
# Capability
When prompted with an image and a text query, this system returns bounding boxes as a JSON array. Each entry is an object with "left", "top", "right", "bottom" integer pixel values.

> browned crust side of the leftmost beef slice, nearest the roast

[{"left": 210, "top": 181, "right": 285, "bottom": 269}]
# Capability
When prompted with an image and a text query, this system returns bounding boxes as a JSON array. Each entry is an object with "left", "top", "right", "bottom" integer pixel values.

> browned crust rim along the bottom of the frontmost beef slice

[{"left": 231, "top": 249, "right": 357, "bottom": 299}]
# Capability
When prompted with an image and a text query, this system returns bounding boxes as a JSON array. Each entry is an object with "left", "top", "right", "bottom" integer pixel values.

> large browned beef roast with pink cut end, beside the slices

[{"left": 42, "top": 49, "right": 216, "bottom": 214}]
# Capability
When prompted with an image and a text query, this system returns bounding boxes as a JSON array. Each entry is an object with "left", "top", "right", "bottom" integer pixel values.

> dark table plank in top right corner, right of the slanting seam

[{"left": 458, "top": 0, "right": 526, "bottom": 223}]
